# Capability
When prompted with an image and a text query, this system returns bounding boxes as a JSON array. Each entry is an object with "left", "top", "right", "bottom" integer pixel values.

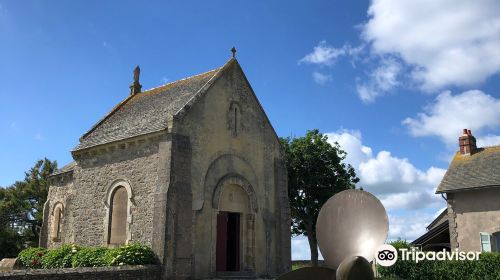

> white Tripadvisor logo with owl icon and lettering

[{"left": 375, "top": 244, "right": 481, "bottom": 266}]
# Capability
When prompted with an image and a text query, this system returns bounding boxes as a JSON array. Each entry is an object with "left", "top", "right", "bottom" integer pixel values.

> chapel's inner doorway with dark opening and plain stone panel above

[{"left": 216, "top": 182, "right": 253, "bottom": 272}]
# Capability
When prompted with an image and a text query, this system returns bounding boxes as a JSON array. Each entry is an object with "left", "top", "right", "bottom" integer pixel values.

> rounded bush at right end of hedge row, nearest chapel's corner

[{"left": 106, "top": 243, "right": 155, "bottom": 266}]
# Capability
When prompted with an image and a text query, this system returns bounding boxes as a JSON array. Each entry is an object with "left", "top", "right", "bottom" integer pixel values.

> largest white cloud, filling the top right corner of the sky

[{"left": 362, "top": 0, "right": 500, "bottom": 90}]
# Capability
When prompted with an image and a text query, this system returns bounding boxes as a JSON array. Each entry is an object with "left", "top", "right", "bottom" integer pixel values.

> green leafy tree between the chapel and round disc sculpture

[{"left": 280, "top": 129, "right": 359, "bottom": 266}]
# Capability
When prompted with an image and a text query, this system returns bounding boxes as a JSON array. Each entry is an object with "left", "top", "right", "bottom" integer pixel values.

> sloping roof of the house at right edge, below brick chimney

[{"left": 436, "top": 146, "right": 500, "bottom": 193}]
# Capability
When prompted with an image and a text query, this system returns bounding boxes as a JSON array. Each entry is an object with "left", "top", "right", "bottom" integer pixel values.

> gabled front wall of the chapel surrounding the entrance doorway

[{"left": 173, "top": 60, "right": 290, "bottom": 279}]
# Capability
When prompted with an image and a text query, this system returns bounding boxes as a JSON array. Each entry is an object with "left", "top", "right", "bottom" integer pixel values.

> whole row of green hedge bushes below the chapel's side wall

[{"left": 18, "top": 243, "right": 155, "bottom": 269}]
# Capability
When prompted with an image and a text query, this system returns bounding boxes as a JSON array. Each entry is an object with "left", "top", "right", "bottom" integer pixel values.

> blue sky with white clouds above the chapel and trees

[{"left": 0, "top": 0, "right": 500, "bottom": 259}]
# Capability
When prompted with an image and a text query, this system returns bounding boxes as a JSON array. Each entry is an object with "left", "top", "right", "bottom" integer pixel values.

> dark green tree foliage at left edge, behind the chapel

[{"left": 0, "top": 158, "right": 57, "bottom": 259}]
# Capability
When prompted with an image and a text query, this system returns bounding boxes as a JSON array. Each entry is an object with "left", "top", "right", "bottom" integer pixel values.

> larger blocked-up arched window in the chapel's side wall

[{"left": 108, "top": 186, "right": 129, "bottom": 245}]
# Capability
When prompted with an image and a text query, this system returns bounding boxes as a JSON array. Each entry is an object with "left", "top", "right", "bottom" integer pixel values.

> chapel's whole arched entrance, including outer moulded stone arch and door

[{"left": 212, "top": 174, "right": 257, "bottom": 272}]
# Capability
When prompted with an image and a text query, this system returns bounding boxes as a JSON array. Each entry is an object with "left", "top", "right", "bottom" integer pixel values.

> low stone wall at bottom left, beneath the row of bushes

[{"left": 0, "top": 265, "right": 160, "bottom": 280}]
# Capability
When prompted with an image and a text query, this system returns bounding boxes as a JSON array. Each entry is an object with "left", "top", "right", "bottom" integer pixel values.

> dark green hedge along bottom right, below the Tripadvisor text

[{"left": 378, "top": 253, "right": 500, "bottom": 280}]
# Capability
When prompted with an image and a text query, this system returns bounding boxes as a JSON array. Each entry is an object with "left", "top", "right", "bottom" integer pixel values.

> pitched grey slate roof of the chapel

[{"left": 74, "top": 63, "right": 224, "bottom": 151}]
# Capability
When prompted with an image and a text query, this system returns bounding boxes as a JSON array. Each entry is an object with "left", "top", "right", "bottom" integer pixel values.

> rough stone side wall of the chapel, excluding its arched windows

[{"left": 41, "top": 136, "right": 164, "bottom": 248}]
